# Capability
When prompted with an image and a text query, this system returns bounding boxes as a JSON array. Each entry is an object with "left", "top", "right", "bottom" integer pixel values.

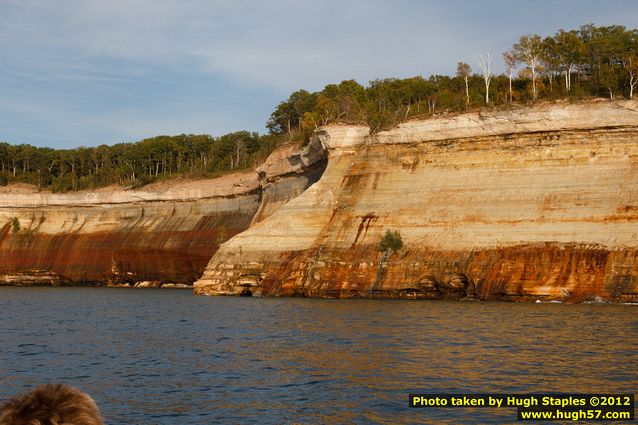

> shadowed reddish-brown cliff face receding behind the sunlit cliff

[{"left": 0, "top": 143, "right": 325, "bottom": 287}]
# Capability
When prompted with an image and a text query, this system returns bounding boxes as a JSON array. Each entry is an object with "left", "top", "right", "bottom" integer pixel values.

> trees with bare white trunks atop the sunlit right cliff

[{"left": 267, "top": 24, "right": 638, "bottom": 137}]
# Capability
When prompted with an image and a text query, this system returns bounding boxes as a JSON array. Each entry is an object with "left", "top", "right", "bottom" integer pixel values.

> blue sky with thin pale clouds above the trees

[{"left": 0, "top": 0, "right": 638, "bottom": 148}]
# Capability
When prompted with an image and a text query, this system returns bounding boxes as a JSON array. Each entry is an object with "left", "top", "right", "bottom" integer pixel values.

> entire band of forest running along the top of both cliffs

[{"left": 0, "top": 24, "right": 638, "bottom": 192}]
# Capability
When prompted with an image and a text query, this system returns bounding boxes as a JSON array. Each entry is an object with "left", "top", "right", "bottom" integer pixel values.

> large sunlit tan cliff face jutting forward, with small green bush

[{"left": 195, "top": 102, "right": 638, "bottom": 301}]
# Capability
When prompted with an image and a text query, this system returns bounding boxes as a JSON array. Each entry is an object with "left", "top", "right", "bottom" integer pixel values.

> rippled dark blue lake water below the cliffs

[{"left": 0, "top": 288, "right": 638, "bottom": 424}]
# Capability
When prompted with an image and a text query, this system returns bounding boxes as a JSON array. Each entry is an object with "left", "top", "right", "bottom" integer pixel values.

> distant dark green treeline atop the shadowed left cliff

[{"left": 0, "top": 131, "right": 281, "bottom": 192}]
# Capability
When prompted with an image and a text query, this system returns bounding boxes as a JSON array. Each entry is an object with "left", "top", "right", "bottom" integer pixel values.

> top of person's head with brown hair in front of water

[{"left": 0, "top": 384, "right": 104, "bottom": 425}]
